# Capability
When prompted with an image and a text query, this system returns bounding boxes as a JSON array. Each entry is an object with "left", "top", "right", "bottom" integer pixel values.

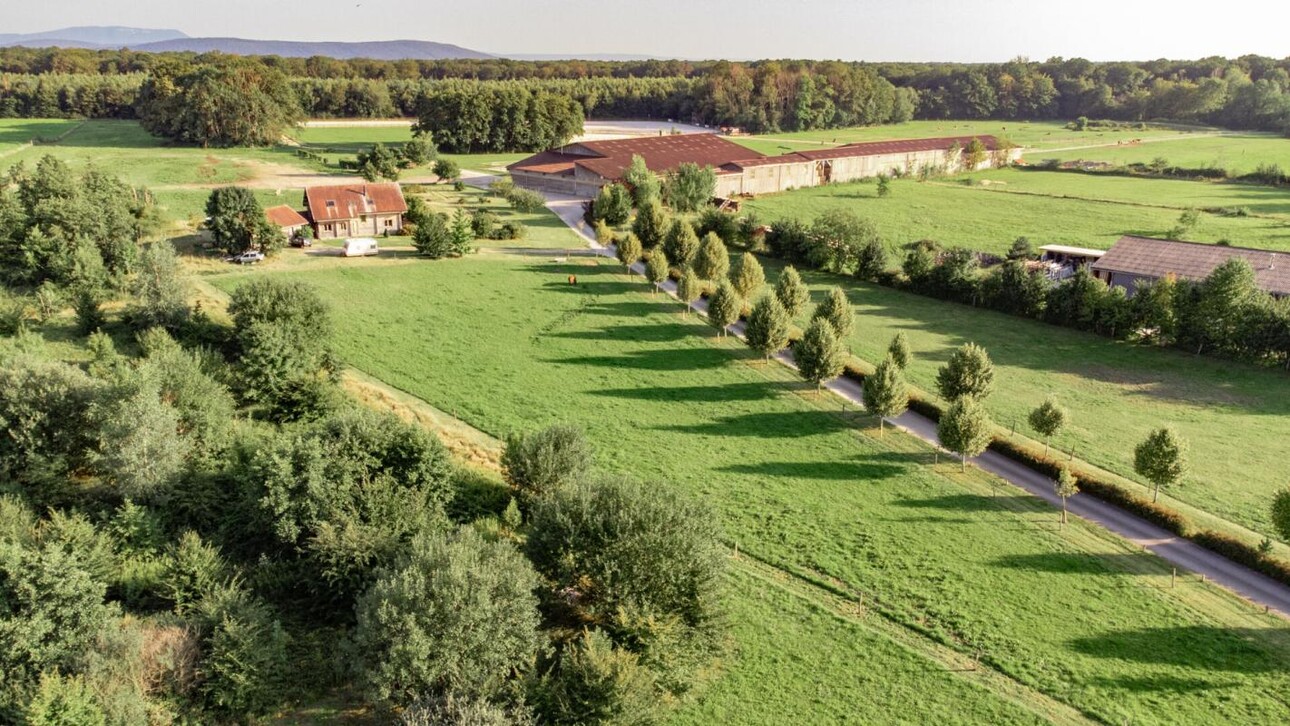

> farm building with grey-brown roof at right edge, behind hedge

[{"left": 1091, "top": 236, "right": 1290, "bottom": 298}]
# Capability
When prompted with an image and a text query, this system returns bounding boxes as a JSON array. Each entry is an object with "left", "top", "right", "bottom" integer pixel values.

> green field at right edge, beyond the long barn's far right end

[{"left": 1047, "top": 132, "right": 1290, "bottom": 174}]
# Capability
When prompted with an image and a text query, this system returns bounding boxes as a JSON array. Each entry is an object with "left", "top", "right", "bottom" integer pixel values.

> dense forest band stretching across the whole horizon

[{"left": 0, "top": 48, "right": 1290, "bottom": 139}]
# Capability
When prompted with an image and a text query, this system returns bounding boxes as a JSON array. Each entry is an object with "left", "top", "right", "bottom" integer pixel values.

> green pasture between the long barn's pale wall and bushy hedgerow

[{"left": 744, "top": 170, "right": 1290, "bottom": 255}]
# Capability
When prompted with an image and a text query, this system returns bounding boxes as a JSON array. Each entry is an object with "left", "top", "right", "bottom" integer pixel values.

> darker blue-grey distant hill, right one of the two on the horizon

[{"left": 130, "top": 37, "right": 493, "bottom": 61}]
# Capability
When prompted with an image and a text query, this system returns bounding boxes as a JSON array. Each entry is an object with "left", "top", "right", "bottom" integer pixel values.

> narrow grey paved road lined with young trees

[{"left": 531, "top": 195, "right": 1290, "bottom": 619}]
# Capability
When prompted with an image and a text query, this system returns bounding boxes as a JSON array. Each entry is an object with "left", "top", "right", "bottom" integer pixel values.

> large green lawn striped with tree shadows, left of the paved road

[{"left": 209, "top": 253, "right": 1290, "bottom": 723}]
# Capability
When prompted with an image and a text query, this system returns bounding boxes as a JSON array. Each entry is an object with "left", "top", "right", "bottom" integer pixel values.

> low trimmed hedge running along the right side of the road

[{"left": 655, "top": 257, "right": 1290, "bottom": 585}]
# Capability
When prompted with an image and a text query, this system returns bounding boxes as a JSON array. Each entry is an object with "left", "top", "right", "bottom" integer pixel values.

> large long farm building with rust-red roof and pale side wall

[{"left": 507, "top": 134, "right": 1020, "bottom": 197}]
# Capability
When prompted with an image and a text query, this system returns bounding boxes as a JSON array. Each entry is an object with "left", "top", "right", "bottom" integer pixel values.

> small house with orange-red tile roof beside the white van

[{"left": 304, "top": 183, "right": 408, "bottom": 240}]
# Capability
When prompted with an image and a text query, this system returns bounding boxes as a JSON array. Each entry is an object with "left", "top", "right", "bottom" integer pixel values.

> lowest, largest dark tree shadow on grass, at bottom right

[{"left": 1069, "top": 625, "right": 1287, "bottom": 673}]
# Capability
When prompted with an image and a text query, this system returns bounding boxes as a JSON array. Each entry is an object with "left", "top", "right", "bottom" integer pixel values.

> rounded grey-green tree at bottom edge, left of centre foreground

[{"left": 355, "top": 527, "right": 543, "bottom": 705}]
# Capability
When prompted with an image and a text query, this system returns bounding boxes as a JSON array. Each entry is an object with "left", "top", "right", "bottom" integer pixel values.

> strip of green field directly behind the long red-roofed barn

[{"left": 730, "top": 121, "right": 1204, "bottom": 155}]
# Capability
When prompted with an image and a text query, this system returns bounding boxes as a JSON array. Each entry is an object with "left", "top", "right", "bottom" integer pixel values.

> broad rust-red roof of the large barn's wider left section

[{"left": 507, "top": 134, "right": 762, "bottom": 179}]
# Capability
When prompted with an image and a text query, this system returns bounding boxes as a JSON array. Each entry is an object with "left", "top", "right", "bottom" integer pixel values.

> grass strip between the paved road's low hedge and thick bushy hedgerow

[{"left": 762, "top": 259, "right": 1290, "bottom": 534}]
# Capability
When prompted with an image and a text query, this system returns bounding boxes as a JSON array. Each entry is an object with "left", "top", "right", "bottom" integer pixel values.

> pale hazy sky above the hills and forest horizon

[{"left": 0, "top": 0, "right": 1290, "bottom": 61}]
